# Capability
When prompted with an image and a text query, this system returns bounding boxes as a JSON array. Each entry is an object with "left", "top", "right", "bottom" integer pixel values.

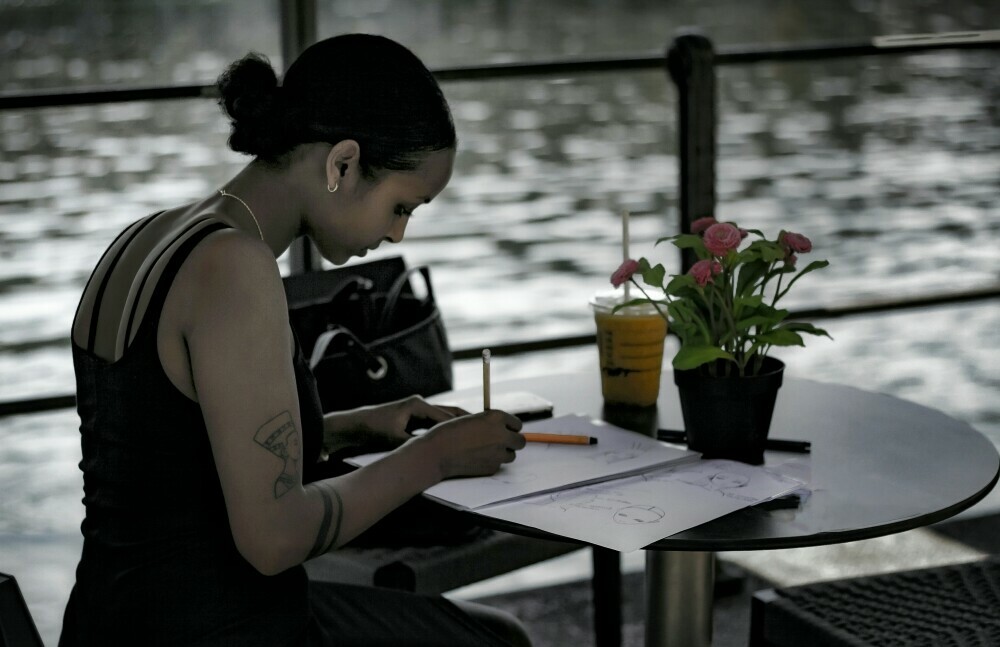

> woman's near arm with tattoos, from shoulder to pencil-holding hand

[{"left": 181, "top": 231, "right": 524, "bottom": 574}]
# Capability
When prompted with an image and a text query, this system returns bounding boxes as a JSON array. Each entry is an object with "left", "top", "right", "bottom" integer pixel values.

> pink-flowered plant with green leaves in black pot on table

[{"left": 611, "top": 218, "right": 829, "bottom": 462}]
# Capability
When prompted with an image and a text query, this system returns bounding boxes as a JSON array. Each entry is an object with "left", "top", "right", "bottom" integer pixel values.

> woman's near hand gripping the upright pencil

[{"left": 413, "top": 409, "right": 525, "bottom": 479}]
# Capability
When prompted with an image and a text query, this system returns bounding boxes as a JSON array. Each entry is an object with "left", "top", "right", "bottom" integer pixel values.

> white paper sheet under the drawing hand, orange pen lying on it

[{"left": 348, "top": 415, "right": 698, "bottom": 509}]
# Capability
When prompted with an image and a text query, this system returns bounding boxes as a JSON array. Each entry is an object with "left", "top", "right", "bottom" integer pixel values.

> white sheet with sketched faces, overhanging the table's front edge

[{"left": 476, "top": 460, "right": 801, "bottom": 552}]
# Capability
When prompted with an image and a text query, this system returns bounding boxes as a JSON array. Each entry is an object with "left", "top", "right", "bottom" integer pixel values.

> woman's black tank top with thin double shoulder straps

[{"left": 59, "top": 223, "right": 322, "bottom": 647}]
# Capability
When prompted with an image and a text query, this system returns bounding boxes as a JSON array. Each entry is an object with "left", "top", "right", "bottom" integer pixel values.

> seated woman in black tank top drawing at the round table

[{"left": 60, "top": 35, "right": 527, "bottom": 646}]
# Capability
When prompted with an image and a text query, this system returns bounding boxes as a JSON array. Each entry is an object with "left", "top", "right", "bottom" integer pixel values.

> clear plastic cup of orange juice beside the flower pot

[{"left": 590, "top": 293, "right": 667, "bottom": 407}]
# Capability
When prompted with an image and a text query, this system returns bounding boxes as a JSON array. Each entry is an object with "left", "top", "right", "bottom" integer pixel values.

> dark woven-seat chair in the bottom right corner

[{"left": 750, "top": 555, "right": 1000, "bottom": 647}]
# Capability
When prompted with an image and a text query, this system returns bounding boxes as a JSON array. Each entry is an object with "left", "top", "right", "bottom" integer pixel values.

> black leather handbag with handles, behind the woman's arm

[{"left": 284, "top": 256, "right": 452, "bottom": 412}]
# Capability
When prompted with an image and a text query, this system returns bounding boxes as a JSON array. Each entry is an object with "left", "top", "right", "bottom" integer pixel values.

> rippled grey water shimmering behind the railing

[{"left": 0, "top": 0, "right": 1000, "bottom": 643}]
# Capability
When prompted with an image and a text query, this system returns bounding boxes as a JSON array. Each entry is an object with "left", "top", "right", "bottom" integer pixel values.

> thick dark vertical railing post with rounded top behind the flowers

[{"left": 666, "top": 33, "right": 717, "bottom": 272}]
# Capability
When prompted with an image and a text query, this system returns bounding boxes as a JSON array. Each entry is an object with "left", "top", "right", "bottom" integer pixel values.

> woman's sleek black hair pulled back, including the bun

[{"left": 217, "top": 34, "right": 456, "bottom": 177}]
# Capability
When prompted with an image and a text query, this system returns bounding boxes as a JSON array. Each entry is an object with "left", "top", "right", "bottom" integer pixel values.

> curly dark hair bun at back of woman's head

[{"left": 216, "top": 52, "right": 292, "bottom": 160}]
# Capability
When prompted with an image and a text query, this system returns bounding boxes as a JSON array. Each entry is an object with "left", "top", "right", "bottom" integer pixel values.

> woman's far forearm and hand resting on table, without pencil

[{"left": 323, "top": 395, "right": 468, "bottom": 454}]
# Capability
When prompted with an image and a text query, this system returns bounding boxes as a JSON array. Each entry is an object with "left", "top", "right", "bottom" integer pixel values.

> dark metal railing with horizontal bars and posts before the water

[{"left": 0, "top": 15, "right": 1000, "bottom": 417}]
